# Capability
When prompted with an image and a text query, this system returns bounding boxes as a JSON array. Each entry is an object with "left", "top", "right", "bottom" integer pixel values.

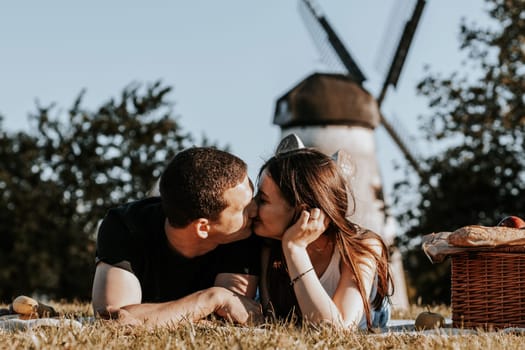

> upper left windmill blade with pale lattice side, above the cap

[{"left": 299, "top": 0, "right": 366, "bottom": 85}]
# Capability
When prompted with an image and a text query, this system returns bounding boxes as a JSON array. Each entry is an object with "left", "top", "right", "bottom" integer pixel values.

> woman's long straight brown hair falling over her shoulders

[{"left": 259, "top": 148, "right": 392, "bottom": 328}]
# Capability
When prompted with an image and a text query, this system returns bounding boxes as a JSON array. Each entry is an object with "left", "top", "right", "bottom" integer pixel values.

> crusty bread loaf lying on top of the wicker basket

[{"left": 448, "top": 225, "right": 525, "bottom": 247}]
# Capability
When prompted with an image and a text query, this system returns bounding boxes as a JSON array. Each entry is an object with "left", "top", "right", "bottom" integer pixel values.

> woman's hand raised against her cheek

[{"left": 282, "top": 208, "right": 329, "bottom": 249}]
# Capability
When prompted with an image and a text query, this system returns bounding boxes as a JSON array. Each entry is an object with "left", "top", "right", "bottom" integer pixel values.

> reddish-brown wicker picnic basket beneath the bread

[{"left": 451, "top": 247, "right": 525, "bottom": 329}]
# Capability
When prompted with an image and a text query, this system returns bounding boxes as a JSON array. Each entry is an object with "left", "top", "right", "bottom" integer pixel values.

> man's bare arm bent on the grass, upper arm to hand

[{"left": 93, "top": 262, "right": 261, "bottom": 326}]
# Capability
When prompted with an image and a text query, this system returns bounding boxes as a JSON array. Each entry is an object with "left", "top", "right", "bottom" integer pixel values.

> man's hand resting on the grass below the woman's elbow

[{"left": 214, "top": 287, "right": 264, "bottom": 325}]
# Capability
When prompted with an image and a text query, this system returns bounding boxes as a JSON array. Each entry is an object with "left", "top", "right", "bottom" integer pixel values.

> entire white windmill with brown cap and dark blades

[{"left": 273, "top": 0, "right": 425, "bottom": 309}]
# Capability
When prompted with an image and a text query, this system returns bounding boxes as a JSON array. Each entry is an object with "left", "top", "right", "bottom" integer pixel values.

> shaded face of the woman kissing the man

[{"left": 253, "top": 171, "right": 295, "bottom": 239}]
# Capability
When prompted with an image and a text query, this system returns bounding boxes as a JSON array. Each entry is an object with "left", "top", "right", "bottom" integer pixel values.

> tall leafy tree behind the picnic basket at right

[{"left": 395, "top": 0, "right": 525, "bottom": 303}]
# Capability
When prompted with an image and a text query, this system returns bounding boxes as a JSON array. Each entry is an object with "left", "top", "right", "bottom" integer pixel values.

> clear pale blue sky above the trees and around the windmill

[{"left": 0, "top": 0, "right": 485, "bottom": 202}]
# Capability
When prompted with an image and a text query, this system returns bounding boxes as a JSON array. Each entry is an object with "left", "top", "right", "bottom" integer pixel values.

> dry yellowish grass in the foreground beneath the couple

[{"left": 0, "top": 303, "right": 525, "bottom": 350}]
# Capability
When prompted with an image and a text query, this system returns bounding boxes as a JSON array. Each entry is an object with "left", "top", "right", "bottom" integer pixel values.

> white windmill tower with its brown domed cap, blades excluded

[{"left": 274, "top": 73, "right": 384, "bottom": 238}]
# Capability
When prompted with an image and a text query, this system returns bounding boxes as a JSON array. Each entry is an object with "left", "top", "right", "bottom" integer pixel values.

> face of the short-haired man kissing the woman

[{"left": 210, "top": 175, "right": 257, "bottom": 244}]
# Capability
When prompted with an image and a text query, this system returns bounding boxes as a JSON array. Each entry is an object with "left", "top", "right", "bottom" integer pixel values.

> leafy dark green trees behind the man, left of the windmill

[{"left": 0, "top": 82, "right": 208, "bottom": 301}]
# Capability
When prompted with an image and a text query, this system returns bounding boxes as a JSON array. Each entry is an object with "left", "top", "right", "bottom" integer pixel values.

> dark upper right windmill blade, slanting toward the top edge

[{"left": 377, "top": 0, "right": 426, "bottom": 106}]
